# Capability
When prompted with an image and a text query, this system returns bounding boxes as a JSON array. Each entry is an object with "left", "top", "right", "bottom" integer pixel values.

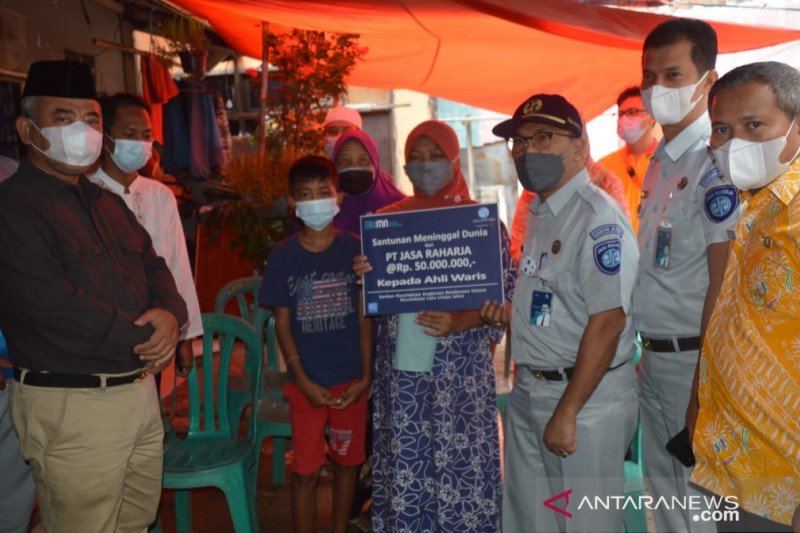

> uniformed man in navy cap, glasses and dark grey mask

[{"left": 481, "top": 94, "right": 639, "bottom": 533}]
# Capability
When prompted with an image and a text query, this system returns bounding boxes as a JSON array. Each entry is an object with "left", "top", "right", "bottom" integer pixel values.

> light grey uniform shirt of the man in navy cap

[{"left": 511, "top": 170, "right": 639, "bottom": 370}]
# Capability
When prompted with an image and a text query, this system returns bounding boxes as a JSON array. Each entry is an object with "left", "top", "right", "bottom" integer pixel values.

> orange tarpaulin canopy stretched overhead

[{"left": 173, "top": 0, "right": 800, "bottom": 117}]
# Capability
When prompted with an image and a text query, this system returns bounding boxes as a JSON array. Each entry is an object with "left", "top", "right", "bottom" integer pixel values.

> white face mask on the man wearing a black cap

[{"left": 31, "top": 120, "right": 103, "bottom": 167}]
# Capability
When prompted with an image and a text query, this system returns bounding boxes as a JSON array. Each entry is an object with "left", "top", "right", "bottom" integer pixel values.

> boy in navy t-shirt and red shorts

[{"left": 258, "top": 156, "right": 373, "bottom": 533}]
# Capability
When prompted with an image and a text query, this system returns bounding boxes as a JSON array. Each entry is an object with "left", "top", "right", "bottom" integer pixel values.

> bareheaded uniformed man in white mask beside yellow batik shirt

[{"left": 633, "top": 19, "right": 739, "bottom": 532}]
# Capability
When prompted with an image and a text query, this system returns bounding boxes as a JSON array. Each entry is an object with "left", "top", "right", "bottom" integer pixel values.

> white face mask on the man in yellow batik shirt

[{"left": 713, "top": 118, "right": 800, "bottom": 191}]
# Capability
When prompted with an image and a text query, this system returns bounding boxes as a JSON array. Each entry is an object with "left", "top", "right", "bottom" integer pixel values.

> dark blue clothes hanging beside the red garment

[{"left": 162, "top": 80, "right": 224, "bottom": 178}]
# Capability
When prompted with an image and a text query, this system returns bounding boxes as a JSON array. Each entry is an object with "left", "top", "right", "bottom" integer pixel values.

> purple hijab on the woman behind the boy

[{"left": 333, "top": 130, "right": 406, "bottom": 235}]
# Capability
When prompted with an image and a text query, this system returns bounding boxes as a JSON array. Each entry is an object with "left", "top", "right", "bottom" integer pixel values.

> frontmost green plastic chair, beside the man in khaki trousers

[{"left": 162, "top": 314, "right": 262, "bottom": 533}]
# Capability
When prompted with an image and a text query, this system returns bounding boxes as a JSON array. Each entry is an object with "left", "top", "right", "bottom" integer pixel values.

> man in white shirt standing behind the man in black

[{"left": 89, "top": 93, "right": 203, "bottom": 369}]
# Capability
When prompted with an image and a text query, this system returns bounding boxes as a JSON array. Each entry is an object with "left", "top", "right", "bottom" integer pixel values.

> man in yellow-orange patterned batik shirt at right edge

[{"left": 686, "top": 62, "right": 800, "bottom": 531}]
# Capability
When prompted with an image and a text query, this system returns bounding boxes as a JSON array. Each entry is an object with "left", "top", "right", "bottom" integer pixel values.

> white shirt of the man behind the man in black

[{"left": 89, "top": 168, "right": 203, "bottom": 339}]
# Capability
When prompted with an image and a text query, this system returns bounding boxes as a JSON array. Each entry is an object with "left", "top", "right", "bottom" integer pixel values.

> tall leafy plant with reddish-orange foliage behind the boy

[{"left": 206, "top": 29, "right": 367, "bottom": 270}]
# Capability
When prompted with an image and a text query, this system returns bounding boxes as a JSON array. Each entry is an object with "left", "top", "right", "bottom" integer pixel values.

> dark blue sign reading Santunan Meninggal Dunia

[{"left": 361, "top": 204, "right": 503, "bottom": 315}]
